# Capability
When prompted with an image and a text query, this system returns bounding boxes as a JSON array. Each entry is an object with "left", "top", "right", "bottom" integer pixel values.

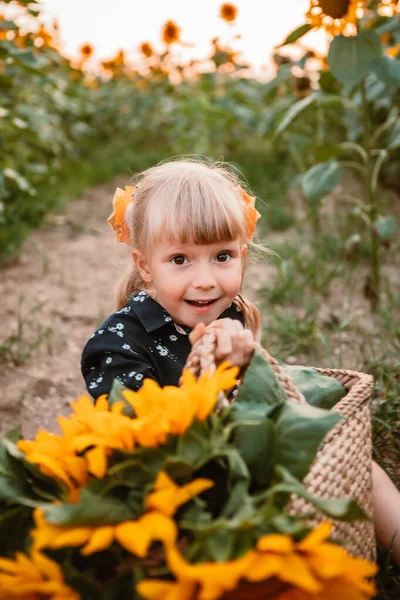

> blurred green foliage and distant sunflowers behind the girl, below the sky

[{"left": 0, "top": 0, "right": 400, "bottom": 262}]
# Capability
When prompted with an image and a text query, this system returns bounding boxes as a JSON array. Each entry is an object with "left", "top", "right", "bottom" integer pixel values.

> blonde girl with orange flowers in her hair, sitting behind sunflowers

[{"left": 82, "top": 160, "right": 400, "bottom": 565}]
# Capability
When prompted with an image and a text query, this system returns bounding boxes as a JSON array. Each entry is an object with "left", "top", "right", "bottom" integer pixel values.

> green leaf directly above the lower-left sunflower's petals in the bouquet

[{"left": 42, "top": 489, "right": 135, "bottom": 527}]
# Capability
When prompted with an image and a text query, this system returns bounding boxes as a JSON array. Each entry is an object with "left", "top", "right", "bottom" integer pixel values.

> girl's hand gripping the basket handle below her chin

[{"left": 189, "top": 319, "right": 257, "bottom": 368}]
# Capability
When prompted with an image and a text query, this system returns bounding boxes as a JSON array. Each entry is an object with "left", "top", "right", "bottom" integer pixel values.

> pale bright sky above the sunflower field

[{"left": 36, "top": 0, "right": 322, "bottom": 74}]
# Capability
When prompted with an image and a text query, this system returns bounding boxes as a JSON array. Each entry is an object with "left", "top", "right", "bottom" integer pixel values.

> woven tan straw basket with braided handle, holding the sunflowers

[{"left": 186, "top": 329, "right": 376, "bottom": 564}]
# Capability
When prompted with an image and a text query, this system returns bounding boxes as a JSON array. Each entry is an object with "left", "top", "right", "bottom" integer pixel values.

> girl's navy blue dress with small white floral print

[{"left": 81, "top": 291, "right": 244, "bottom": 399}]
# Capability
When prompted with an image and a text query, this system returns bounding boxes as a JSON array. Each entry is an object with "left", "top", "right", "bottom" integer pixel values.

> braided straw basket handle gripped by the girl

[{"left": 184, "top": 326, "right": 307, "bottom": 408}]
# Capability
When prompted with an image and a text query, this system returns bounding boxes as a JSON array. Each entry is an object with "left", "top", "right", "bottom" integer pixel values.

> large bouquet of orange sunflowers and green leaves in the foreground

[{"left": 0, "top": 352, "right": 376, "bottom": 600}]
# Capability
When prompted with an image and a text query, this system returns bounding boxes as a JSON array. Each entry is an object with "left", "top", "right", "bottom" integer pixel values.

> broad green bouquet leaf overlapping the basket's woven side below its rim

[{"left": 275, "top": 402, "right": 342, "bottom": 480}]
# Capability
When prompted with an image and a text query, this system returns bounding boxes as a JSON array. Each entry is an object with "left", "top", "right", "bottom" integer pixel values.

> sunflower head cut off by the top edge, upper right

[{"left": 306, "top": 0, "right": 366, "bottom": 35}]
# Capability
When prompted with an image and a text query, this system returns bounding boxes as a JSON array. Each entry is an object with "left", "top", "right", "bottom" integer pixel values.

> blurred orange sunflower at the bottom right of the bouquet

[{"left": 138, "top": 523, "right": 377, "bottom": 600}]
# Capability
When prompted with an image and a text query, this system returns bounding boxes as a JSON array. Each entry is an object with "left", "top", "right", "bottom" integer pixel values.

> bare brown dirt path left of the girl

[{"left": 0, "top": 178, "right": 268, "bottom": 438}]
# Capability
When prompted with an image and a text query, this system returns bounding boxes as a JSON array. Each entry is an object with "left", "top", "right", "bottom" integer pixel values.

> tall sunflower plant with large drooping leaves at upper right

[{"left": 275, "top": 0, "right": 400, "bottom": 311}]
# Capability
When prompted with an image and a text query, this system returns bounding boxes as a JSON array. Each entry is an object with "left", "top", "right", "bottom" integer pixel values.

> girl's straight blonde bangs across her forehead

[{"left": 143, "top": 170, "right": 246, "bottom": 247}]
